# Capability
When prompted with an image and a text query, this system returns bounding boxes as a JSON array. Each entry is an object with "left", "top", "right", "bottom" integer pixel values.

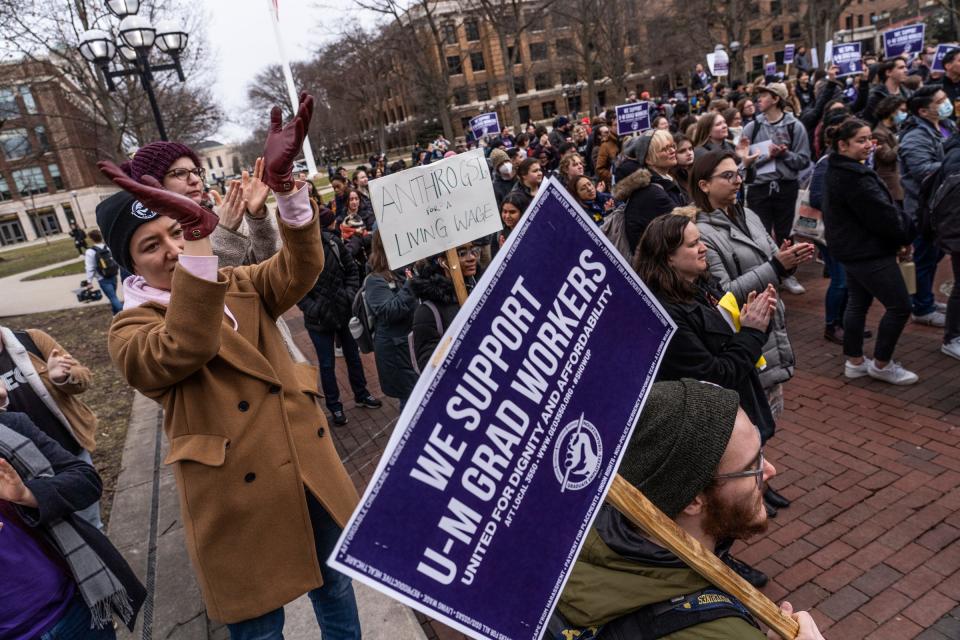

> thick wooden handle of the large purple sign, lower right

[{"left": 607, "top": 474, "right": 800, "bottom": 640}]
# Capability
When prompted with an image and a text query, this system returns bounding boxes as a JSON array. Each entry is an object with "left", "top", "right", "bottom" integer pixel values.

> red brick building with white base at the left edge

[{"left": 0, "top": 57, "right": 116, "bottom": 246}]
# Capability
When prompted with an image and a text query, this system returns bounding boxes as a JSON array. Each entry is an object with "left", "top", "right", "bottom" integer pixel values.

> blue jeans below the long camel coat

[{"left": 227, "top": 490, "right": 360, "bottom": 640}]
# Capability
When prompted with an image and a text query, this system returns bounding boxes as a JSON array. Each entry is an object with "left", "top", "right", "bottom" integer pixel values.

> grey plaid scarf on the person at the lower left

[{"left": 0, "top": 424, "right": 133, "bottom": 629}]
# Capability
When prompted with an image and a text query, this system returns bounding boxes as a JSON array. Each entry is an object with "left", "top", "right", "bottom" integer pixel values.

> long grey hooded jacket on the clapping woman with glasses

[{"left": 697, "top": 208, "right": 797, "bottom": 389}]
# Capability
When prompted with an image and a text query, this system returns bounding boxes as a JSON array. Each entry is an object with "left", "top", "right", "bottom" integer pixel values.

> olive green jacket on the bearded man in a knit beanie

[{"left": 557, "top": 506, "right": 766, "bottom": 640}]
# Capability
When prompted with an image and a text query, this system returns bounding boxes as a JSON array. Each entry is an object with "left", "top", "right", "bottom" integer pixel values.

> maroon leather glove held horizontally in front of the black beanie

[{"left": 97, "top": 160, "right": 219, "bottom": 240}]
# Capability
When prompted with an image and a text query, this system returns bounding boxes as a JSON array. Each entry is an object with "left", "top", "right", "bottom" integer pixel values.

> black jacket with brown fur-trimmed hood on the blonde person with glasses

[{"left": 613, "top": 159, "right": 689, "bottom": 252}]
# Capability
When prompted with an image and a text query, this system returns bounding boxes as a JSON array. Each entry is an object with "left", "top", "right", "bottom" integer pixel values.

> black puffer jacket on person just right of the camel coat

[{"left": 297, "top": 231, "right": 360, "bottom": 333}]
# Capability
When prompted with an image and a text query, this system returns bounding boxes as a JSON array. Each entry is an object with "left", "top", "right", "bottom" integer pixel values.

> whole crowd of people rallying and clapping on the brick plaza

[{"left": 0, "top": 40, "right": 960, "bottom": 640}]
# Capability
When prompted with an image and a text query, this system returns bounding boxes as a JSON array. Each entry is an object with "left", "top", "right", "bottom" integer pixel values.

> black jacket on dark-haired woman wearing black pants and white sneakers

[{"left": 823, "top": 153, "right": 915, "bottom": 262}]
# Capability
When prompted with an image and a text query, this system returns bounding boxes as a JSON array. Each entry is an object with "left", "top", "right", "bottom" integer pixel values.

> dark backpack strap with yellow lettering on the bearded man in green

[{"left": 541, "top": 587, "right": 760, "bottom": 640}]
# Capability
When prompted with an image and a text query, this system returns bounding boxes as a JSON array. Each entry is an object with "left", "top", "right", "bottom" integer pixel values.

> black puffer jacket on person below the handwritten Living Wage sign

[{"left": 410, "top": 262, "right": 479, "bottom": 371}]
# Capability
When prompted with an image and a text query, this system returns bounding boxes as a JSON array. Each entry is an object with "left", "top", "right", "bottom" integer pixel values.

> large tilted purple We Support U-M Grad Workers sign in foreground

[{"left": 331, "top": 179, "right": 674, "bottom": 640}]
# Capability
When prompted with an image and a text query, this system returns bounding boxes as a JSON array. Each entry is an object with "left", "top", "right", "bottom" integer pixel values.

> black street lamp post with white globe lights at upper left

[{"left": 77, "top": 0, "right": 188, "bottom": 140}]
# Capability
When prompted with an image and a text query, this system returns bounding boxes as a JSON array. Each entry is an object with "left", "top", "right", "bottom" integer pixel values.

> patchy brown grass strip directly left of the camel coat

[{"left": 3, "top": 308, "right": 133, "bottom": 524}]
